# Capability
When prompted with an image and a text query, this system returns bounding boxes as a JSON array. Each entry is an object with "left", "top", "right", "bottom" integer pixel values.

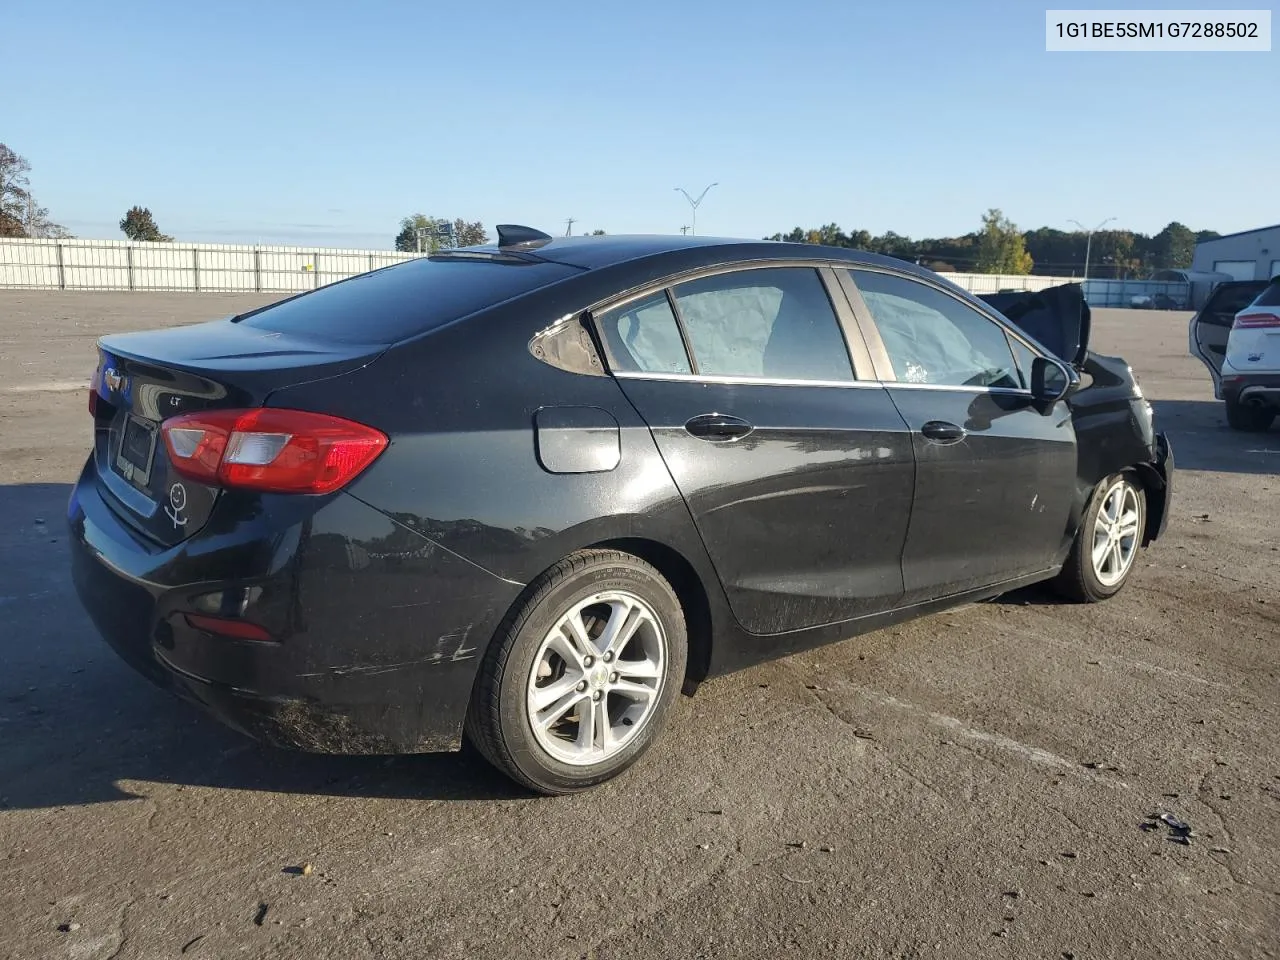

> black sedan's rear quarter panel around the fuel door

[{"left": 270, "top": 305, "right": 747, "bottom": 660}]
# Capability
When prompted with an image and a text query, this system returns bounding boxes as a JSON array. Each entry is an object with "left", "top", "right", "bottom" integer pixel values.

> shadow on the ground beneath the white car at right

[{"left": 1151, "top": 399, "right": 1280, "bottom": 476}]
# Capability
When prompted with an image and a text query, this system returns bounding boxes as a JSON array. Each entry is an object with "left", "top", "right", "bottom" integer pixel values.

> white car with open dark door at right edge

[{"left": 1187, "top": 276, "right": 1280, "bottom": 433}]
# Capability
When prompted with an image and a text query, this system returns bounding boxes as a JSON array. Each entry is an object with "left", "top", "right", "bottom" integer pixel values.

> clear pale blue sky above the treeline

[{"left": 0, "top": 0, "right": 1280, "bottom": 247}]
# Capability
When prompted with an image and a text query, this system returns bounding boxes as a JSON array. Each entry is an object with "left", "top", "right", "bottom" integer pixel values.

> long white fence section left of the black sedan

[{"left": 0, "top": 239, "right": 417, "bottom": 293}]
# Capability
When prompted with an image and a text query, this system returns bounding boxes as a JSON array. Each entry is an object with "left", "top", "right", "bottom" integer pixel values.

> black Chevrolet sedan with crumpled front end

[{"left": 69, "top": 227, "right": 1172, "bottom": 794}]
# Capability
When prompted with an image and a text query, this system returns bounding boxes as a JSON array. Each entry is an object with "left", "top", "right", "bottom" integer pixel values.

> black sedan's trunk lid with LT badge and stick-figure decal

[{"left": 91, "top": 320, "right": 385, "bottom": 547}]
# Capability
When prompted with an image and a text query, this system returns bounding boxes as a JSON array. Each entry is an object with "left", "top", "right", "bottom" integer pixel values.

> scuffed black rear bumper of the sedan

[{"left": 68, "top": 465, "right": 521, "bottom": 754}]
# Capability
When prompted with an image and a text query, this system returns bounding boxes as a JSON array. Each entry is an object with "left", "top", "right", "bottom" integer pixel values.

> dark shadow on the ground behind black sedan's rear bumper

[{"left": 0, "top": 484, "right": 530, "bottom": 809}]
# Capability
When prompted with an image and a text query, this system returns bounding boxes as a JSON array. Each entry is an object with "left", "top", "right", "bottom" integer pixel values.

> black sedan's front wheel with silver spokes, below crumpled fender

[{"left": 1053, "top": 474, "right": 1147, "bottom": 603}]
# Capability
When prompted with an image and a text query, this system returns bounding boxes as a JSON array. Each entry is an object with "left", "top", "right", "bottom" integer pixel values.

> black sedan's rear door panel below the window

[{"left": 622, "top": 378, "right": 915, "bottom": 634}]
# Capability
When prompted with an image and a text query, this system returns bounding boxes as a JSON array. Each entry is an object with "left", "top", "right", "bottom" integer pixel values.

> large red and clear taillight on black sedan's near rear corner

[{"left": 160, "top": 407, "right": 388, "bottom": 493}]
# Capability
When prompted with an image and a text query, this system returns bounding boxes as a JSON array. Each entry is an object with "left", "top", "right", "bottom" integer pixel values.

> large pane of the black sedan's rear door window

[{"left": 672, "top": 266, "right": 854, "bottom": 383}]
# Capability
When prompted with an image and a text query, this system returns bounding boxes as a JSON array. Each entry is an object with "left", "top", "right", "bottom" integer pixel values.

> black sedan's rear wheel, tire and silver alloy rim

[{"left": 466, "top": 550, "right": 689, "bottom": 795}]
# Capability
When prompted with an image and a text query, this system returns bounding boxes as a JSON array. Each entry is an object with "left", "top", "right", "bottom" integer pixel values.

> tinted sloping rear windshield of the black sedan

[{"left": 241, "top": 259, "right": 580, "bottom": 343}]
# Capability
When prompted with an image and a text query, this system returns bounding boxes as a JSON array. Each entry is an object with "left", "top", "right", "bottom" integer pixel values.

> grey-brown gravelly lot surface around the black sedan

[{"left": 0, "top": 291, "right": 1280, "bottom": 960}]
